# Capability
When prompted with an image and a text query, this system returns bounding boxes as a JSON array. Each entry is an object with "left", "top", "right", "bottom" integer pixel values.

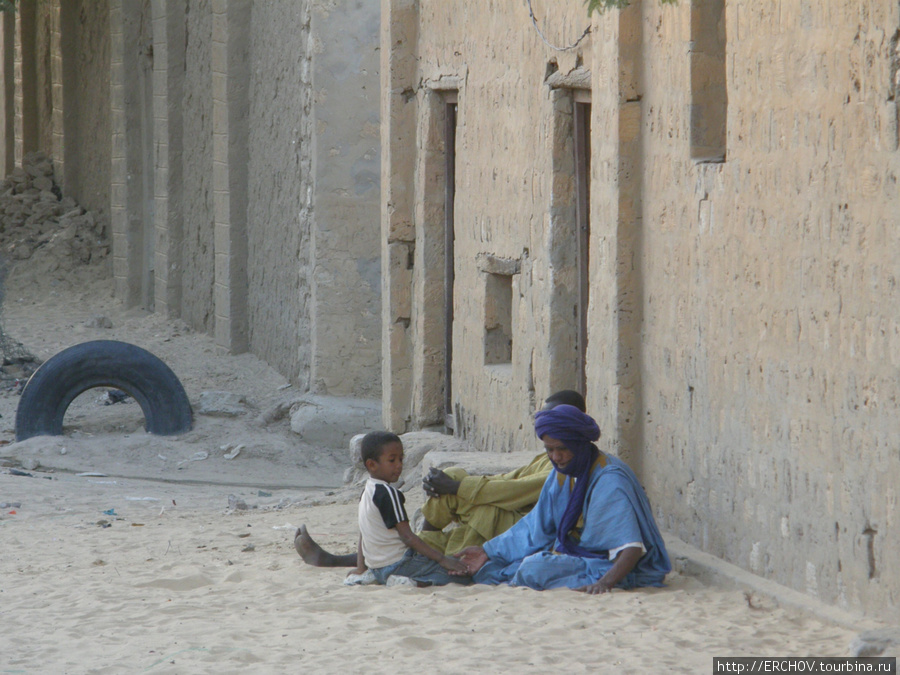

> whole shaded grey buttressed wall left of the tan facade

[{"left": 0, "top": 0, "right": 381, "bottom": 399}]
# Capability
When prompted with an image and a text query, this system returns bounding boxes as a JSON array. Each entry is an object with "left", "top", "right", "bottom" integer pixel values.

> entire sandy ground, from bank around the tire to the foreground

[{"left": 0, "top": 252, "right": 880, "bottom": 674}]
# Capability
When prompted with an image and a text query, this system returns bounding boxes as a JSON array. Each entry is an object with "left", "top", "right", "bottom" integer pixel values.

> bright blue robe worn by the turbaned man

[{"left": 474, "top": 453, "right": 672, "bottom": 590}]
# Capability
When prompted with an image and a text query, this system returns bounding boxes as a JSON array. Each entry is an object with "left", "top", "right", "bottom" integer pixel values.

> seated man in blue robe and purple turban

[{"left": 461, "top": 405, "right": 672, "bottom": 593}]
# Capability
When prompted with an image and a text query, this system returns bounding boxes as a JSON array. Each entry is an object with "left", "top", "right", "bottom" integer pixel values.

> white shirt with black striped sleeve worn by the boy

[{"left": 359, "top": 477, "right": 409, "bottom": 569}]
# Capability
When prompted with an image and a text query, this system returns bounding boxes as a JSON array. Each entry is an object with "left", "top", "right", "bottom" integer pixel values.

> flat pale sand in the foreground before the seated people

[{"left": 0, "top": 474, "right": 853, "bottom": 673}]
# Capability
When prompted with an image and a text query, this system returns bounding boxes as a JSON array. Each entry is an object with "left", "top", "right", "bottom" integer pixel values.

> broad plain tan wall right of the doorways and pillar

[{"left": 641, "top": 1, "right": 900, "bottom": 620}]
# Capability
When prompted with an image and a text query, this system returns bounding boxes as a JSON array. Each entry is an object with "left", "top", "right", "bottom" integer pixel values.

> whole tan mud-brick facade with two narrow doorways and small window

[{"left": 381, "top": 0, "right": 900, "bottom": 621}]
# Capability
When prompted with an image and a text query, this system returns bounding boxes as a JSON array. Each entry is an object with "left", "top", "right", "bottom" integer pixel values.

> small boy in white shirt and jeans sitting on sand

[{"left": 352, "top": 431, "right": 471, "bottom": 586}]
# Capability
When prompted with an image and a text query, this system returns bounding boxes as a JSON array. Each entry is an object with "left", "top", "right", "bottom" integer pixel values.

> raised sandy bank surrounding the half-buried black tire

[{"left": 0, "top": 262, "right": 346, "bottom": 487}]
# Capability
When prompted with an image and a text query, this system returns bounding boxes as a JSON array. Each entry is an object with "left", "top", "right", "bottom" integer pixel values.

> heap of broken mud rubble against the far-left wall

[{"left": 0, "top": 152, "right": 109, "bottom": 272}]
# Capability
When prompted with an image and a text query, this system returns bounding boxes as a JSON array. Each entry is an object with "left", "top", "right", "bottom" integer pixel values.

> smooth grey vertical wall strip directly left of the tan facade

[{"left": 310, "top": 0, "right": 381, "bottom": 398}]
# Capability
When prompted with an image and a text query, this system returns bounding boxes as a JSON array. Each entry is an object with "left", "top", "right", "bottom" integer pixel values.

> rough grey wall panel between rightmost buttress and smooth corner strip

[{"left": 247, "top": 0, "right": 313, "bottom": 389}]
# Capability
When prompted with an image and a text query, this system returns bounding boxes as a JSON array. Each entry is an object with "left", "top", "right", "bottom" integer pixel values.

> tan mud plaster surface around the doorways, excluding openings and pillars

[{"left": 400, "top": 0, "right": 900, "bottom": 620}]
